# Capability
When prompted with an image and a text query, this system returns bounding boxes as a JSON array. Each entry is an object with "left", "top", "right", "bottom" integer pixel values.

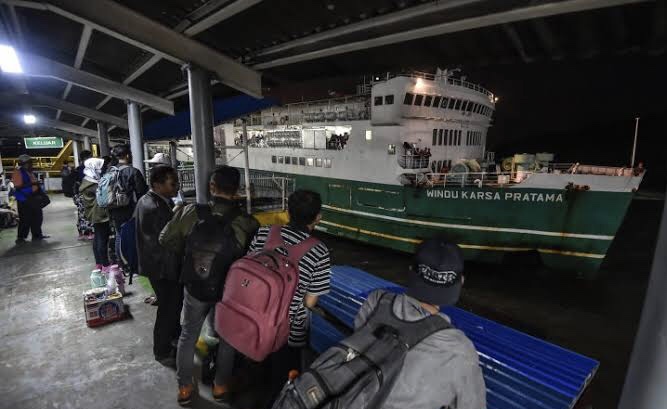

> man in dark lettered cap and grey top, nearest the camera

[{"left": 354, "top": 238, "right": 486, "bottom": 409}]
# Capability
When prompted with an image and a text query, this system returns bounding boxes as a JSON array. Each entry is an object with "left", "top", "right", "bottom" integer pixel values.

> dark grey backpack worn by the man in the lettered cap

[{"left": 273, "top": 293, "right": 451, "bottom": 409}]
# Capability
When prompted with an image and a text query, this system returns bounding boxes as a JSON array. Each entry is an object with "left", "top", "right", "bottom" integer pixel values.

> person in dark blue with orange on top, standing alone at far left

[{"left": 12, "top": 155, "right": 49, "bottom": 244}]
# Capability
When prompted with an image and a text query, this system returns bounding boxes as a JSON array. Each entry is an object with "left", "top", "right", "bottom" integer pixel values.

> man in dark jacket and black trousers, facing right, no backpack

[{"left": 134, "top": 165, "right": 183, "bottom": 367}]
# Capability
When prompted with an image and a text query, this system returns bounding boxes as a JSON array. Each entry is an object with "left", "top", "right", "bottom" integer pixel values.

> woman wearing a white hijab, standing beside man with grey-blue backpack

[{"left": 79, "top": 158, "right": 111, "bottom": 271}]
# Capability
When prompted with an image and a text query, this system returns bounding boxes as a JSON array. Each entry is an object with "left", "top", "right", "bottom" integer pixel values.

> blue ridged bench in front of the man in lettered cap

[{"left": 311, "top": 266, "right": 599, "bottom": 409}]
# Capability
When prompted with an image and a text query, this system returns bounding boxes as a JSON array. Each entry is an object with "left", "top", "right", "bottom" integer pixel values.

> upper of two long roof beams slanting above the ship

[{"left": 253, "top": 0, "right": 484, "bottom": 57}]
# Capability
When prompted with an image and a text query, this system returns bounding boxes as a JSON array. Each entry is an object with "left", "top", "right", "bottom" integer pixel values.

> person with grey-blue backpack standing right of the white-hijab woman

[{"left": 109, "top": 145, "right": 148, "bottom": 266}]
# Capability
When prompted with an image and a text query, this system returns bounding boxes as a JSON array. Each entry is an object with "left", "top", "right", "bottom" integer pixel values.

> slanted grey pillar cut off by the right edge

[{"left": 618, "top": 190, "right": 667, "bottom": 409}]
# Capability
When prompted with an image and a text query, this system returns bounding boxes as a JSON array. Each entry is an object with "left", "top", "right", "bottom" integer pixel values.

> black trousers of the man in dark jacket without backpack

[{"left": 149, "top": 278, "right": 183, "bottom": 359}]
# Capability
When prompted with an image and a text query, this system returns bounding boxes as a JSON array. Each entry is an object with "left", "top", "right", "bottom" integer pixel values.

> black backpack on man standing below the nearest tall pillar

[{"left": 181, "top": 205, "right": 241, "bottom": 302}]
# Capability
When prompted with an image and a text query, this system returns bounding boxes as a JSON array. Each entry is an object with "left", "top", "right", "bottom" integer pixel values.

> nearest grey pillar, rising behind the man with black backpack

[{"left": 187, "top": 65, "right": 215, "bottom": 204}]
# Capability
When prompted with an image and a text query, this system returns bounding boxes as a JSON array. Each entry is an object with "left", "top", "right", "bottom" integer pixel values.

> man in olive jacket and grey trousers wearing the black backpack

[{"left": 158, "top": 166, "right": 259, "bottom": 406}]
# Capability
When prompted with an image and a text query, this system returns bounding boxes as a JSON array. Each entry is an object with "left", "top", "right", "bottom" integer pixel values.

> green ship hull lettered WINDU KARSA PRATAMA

[{"left": 264, "top": 174, "right": 633, "bottom": 273}]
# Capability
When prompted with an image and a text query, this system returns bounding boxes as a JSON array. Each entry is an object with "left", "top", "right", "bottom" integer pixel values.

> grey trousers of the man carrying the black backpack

[{"left": 176, "top": 288, "right": 234, "bottom": 386}]
